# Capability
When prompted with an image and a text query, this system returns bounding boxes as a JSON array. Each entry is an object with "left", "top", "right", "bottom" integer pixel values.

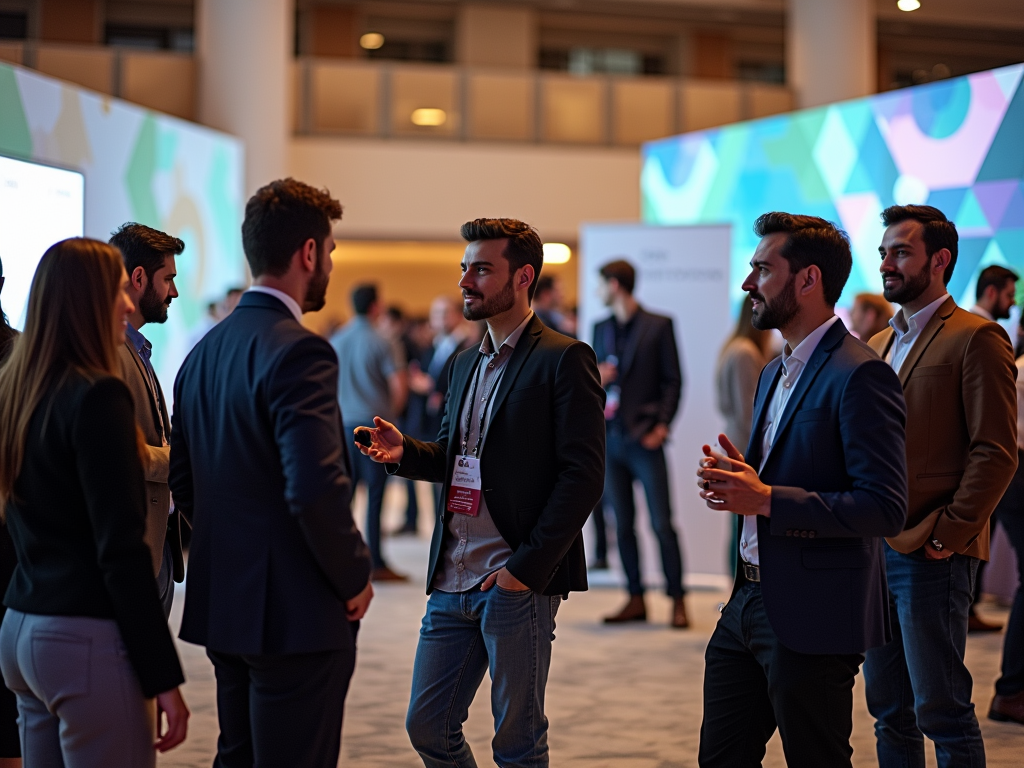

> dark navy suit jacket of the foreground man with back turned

[{"left": 170, "top": 293, "right": 370, "bottom": 654}]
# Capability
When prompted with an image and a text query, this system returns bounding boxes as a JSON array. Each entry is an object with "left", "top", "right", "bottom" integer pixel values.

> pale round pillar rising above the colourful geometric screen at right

[{"left": 785, "top": 0, "right": 878, "bottom": 106}]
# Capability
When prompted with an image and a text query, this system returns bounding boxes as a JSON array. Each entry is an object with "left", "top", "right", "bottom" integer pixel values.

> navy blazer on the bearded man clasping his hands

[{"left": 733, "top": 321, "right": 907, "bottom": 653}]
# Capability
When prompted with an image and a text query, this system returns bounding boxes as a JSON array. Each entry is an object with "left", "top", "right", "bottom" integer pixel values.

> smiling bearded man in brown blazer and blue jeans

[{"left": 864, "top": 206, "right": 1017, "bottom": 768}]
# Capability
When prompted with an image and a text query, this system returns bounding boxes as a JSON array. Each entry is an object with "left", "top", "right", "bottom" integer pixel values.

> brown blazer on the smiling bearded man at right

[{"left": 868, "top": 297, "right": 1017, "bottom": 560}]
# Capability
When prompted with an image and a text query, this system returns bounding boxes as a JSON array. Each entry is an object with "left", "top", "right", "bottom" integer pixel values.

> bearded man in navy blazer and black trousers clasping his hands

[{"left": 697, "top": 213, "right": 906, "bottom": 768}]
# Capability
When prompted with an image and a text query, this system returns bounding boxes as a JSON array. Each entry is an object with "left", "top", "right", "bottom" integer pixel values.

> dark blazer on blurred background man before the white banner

[{"left": 594, "top": 308, "right": 683, "bottom": 440}]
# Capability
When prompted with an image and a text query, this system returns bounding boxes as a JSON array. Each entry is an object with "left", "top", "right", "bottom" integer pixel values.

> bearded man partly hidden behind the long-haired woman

[{"left": 111, "top": 222, "right": 185, "bottom": 617}]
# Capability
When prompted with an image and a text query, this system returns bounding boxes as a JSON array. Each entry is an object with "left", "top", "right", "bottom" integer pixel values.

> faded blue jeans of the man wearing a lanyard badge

[{"left": 406, "top": 585, "right": 561, "bottom": 768}]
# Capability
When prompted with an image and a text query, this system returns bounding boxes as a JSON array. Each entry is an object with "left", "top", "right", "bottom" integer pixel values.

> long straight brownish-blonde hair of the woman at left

[{"left": 0, "top": 238, "right": 124, "bottom": 515}]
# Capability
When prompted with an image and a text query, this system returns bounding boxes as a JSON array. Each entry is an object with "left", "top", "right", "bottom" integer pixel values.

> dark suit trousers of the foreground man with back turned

[{"left": 207, "top": 650, "right": 355, "bottom": 768}]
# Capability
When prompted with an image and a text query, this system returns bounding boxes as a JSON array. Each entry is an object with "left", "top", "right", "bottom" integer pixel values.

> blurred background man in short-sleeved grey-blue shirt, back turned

[{"left": 331, "top": 285, "right": 409, "bottom": 582}]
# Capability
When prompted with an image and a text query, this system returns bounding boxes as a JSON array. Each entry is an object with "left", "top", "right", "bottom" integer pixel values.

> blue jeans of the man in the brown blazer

[{"left": 864, "top": 545, "right": 985, "bottom": 768}]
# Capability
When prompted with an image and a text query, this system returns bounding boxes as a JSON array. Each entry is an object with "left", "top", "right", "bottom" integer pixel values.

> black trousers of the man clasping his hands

[{"left": 697, "top": 583, "right": 864, "bottom": 768}]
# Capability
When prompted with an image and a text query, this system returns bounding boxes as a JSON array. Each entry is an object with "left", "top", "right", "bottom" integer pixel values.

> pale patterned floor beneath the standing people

[{"left": 159, "top": 489, "right": 1024, "bottom": 768}]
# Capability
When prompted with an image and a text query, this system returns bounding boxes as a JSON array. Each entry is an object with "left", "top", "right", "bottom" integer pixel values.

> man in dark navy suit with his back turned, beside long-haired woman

[{"left": 170, "top": 179, "right": 373, "bottom": 768}]
